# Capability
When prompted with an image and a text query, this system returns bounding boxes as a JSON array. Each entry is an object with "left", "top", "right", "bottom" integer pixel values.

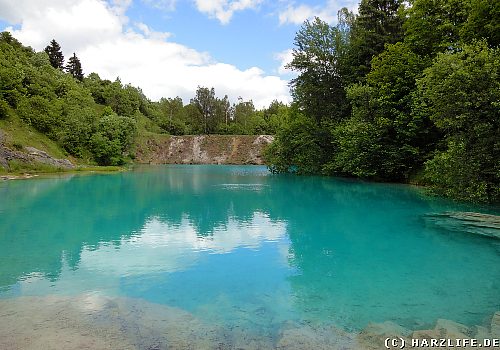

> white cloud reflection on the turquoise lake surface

[{"left": 79, "top": 212, "right": 286, "bottom": 276}]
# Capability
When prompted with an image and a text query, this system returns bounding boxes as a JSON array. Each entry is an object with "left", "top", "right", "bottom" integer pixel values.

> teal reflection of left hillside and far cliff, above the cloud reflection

[{"left": 0, "top": 167, "right": 286, "bottom": 286}]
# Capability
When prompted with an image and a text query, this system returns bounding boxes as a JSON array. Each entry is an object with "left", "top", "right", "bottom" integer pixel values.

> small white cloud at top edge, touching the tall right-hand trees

[{"left": 278, "top": 0, "right": 358, "bottom": 25}]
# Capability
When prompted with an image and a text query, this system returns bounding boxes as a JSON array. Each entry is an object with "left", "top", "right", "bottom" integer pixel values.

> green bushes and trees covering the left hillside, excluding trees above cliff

[{"left": 0, "top": 33, "right": 146, "bottom": 168}]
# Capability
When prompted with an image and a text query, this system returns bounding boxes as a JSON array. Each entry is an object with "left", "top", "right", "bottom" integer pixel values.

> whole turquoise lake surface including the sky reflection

[{"left": 0, "top": 165, "right": 500, "bottom": 349}]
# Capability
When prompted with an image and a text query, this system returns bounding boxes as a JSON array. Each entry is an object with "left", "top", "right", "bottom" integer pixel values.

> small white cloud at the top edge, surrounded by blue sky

[{"left": 195, "top": 0, "right": 263, "bottom": 24}]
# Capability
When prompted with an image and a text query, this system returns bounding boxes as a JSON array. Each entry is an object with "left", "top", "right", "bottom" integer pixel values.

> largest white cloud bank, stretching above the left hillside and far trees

[{"left": 0, "top": 0, "right": 290, "bottom": 107}]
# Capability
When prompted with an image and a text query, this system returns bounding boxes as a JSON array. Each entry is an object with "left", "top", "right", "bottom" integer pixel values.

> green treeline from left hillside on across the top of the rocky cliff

[{"left": 0, "top": 32, "right": 289, "bottom": 165}]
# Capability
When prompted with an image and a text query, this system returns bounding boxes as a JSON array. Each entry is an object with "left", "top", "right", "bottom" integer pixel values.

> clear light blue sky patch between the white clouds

[{"left": 123, "top": 1, "right": 300, "bottom": 74}]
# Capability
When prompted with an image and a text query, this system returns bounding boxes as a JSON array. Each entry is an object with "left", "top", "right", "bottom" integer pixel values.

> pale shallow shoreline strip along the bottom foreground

[{"left": 0, "top": 293, "right": 500, "bottom": 350}]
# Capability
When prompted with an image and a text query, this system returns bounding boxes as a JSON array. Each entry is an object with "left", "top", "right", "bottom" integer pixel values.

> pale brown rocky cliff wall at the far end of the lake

[{"left": 136, "top": 135, "right": 274, "bottom": 164}]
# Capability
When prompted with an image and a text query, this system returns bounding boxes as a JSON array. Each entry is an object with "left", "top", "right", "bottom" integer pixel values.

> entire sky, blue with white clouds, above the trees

[{"left": 0, "top": 0, "right": 358, "bottom": 107}]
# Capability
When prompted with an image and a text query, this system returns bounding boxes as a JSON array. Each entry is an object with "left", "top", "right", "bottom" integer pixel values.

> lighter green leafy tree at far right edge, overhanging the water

[{"left": 418, "top": 42, "right": 500, "bottom": 202}]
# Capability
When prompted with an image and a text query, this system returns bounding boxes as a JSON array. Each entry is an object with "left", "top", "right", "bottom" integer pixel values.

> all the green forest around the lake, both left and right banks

[{"left": 0, "top": 0, "right": 500, "bottom": 203}]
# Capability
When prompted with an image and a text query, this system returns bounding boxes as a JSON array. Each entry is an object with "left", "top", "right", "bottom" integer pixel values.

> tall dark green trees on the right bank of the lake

[{"left": 266, "top": 0, "right": 500, "bottom": 202}]
